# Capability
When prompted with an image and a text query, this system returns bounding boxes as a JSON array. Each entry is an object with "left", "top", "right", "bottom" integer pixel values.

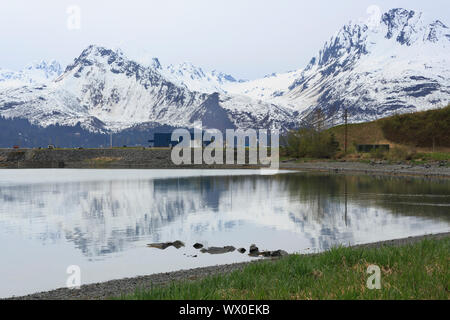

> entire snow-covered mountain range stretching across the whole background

[{"left": 0, "top": 9, "right": 450, "bottom": 135}]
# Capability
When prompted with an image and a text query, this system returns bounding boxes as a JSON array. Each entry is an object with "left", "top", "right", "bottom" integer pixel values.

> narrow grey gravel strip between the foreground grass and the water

[{"left": 9, "top": 233, "right": 450, "bottom": 300}]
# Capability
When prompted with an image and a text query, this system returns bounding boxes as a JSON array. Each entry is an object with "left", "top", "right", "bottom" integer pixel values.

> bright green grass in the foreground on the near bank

[{"left": 120, "top": 238, "right": 450, "bottom": 300}]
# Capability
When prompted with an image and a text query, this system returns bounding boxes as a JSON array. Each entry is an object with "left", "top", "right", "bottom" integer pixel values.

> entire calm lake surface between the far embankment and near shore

[{"left": 0, "top": 169, "right": 450, "bottom": 297}]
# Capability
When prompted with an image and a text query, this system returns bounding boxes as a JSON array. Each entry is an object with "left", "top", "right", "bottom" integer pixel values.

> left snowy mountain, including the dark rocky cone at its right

[{"left": 0, "top": 46, "right": 298, "bottom": 131}]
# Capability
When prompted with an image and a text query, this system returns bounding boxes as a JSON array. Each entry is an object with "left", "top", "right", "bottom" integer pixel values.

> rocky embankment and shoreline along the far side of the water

[{"left": 0, "top": 148, "right": 450, "bottom": 178}]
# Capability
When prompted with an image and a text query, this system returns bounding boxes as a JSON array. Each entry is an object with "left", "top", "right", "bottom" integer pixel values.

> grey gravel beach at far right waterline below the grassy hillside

[{"left": 280, "top": 161, "right": 450, "bottom": 178}]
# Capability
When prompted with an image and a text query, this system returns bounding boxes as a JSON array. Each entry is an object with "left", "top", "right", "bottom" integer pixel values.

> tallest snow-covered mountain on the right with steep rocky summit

[{"left": 229, "top": 9, "right": 450, "bottom": 124}]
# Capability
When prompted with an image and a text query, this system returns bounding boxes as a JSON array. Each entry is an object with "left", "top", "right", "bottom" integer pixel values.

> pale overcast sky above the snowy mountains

[{"left": 0, "top": 0, "right": 450, "bottom": 79}]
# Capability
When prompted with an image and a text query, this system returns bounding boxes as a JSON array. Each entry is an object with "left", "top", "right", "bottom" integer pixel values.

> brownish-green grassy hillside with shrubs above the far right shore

[{"left": 284, "top": 105, "right": 450, "bottom": 163}]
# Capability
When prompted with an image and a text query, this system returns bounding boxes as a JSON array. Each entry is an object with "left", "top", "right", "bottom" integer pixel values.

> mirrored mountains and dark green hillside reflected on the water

[{"left": 0, "top": 171, "right": 450, "bottom": 257}]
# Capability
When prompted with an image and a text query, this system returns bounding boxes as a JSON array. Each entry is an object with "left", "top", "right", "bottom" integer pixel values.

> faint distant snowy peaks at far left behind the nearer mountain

[{"left": 0, "top": 60, "right": 63, "bottom": 86}]
